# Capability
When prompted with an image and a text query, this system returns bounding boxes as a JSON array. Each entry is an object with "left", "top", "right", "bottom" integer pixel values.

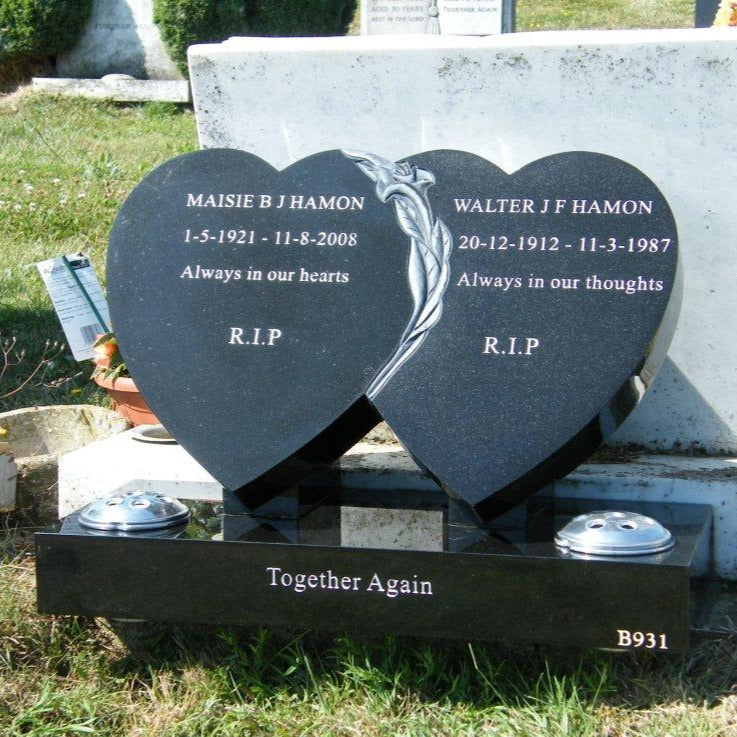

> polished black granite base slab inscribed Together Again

[{"left": 36, "top": 492, "right": 711, "bottom": 652}]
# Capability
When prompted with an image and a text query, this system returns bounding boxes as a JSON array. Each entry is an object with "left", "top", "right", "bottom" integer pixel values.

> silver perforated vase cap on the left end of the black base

[{"left": 79, "top": 491, "right": 189, "bottom": 532}]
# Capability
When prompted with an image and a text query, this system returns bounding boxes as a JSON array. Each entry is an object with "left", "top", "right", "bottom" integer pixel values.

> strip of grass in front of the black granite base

[{"left": 0, "top": 552, "right": 737, "bottom": 737}]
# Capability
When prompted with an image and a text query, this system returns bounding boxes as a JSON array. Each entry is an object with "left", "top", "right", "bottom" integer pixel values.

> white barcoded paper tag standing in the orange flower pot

[{"left": 36, "top": 253, "right": 110, "bottom": 361}]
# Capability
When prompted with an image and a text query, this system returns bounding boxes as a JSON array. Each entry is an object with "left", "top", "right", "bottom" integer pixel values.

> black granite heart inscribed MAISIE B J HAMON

[{"left": 108, "top": 149, "right": 412, "bottom": 502}]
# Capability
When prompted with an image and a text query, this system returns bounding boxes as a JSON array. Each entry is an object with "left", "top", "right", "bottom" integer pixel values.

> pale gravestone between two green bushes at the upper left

[{"left": 56, "top": 0, "right": 182, "bottom": 79}]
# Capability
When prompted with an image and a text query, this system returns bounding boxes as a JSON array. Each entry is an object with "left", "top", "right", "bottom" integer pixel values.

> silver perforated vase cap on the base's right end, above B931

[{"left": 555, "top": 511, "right": 675, "bottom": 556}]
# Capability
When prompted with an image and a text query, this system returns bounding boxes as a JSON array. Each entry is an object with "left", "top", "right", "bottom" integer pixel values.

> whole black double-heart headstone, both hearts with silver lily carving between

[{"left": 108, "top": 150, "right": 680, "bottom": 517}]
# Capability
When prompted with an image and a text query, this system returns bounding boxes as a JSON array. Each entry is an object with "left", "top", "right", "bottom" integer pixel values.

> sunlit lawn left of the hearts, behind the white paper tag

[{"left": 0, "top": 94, "right": 197, "bottom": 409}]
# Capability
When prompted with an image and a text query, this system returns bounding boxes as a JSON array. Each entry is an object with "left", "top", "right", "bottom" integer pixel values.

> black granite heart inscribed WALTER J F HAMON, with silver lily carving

[{"left": 362, "top": 151, "right": 680, "bottom": 517}]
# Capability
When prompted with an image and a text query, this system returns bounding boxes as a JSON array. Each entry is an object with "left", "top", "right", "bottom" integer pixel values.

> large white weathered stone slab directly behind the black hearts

[{"left": 190, "top": 29, "right": 737, "bottom": 453}]
